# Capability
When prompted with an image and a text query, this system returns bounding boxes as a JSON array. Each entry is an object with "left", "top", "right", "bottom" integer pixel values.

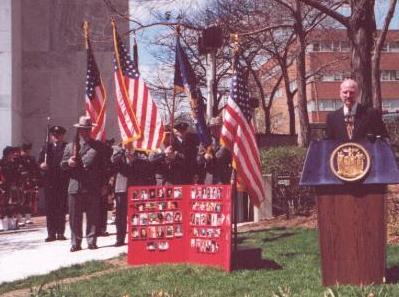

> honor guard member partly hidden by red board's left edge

[{"left": 111, "top": 143, "right": 155, "bottom": 246}]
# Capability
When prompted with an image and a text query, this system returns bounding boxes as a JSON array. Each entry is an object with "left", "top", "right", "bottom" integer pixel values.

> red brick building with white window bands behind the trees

[{"left": 257, "top": 30, "right": 399, "bottom": 134}]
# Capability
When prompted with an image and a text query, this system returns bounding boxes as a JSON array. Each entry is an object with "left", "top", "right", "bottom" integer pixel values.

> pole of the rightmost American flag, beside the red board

[{"left": 231, "top": 33, "right": 239, "bottom": 256}]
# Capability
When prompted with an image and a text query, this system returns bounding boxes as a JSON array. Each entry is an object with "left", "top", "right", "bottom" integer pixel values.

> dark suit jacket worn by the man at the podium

[{"left": 326, "top": 104, "right": 388, "bottom": 141}]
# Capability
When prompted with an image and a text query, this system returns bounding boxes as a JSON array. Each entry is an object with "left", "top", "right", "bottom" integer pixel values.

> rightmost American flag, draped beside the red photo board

[{"left": 220, "top": 59, "right": 266, "bottom": 205}]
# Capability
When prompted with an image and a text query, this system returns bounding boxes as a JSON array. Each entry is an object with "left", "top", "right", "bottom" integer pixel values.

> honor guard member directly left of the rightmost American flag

[{"left": 197, "top": 116, "right": 232, "bottom": 185}]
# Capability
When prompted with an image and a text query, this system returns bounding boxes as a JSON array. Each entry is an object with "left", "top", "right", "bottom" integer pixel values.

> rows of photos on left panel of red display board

[{"left": 129, "top": 187, "right": 183, "bottom": 251}]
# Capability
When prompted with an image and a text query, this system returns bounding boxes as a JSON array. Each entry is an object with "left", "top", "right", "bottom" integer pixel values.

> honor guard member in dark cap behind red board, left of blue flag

[{"left": 150, "top": 120, "right": 198, "bottom": 185}]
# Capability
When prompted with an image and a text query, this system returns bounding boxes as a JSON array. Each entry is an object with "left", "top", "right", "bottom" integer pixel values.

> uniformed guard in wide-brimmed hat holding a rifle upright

[{"left": 61, "top": 116, "right": 105, "bottom": 252}]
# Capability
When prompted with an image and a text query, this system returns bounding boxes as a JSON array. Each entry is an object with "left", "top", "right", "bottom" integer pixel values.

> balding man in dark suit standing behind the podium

[{"left": 326, "top": 78, "right": 388, "bottom": 142}]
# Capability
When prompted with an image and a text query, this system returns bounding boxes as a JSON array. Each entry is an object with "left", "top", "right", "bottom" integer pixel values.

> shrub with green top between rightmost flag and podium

[{"left": 261, "top": 146, "right": 315, "bottom": 218}]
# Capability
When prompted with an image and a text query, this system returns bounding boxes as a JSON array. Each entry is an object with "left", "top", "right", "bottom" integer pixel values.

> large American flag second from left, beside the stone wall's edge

[{"left": 114, "top": 23, "right": 164, "bottom": 151}]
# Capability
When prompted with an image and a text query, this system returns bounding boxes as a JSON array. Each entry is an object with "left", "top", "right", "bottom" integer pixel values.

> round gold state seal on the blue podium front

[{"left": 330, "top": 142, "right": 371, "bottom": 182}]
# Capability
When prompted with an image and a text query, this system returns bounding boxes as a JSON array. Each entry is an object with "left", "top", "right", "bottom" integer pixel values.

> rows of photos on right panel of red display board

[{"left": 190, "top": 186, "right": 225, "bottom": 254}]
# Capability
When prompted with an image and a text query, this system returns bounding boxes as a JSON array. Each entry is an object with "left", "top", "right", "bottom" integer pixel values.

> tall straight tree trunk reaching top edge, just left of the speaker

[{"left": 295, "top": 0, "right": 310, "bottom": 147}]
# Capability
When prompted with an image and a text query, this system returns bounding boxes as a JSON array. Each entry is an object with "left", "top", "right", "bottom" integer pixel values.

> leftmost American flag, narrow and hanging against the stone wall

[{"left": 85, "top": 40, "right": 106, "bottom": 141}]
